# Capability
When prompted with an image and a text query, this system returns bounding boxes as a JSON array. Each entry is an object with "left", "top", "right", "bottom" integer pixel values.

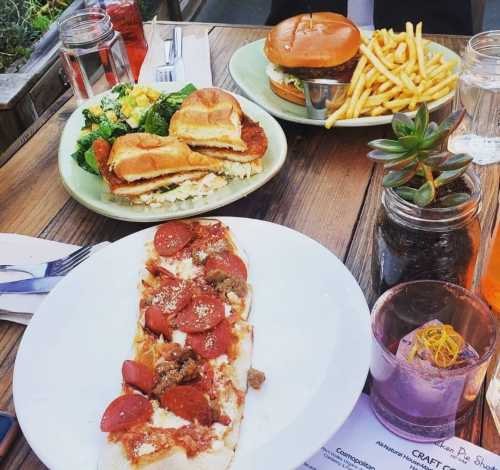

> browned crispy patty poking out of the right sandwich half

[{"left": 196, "top": 116, "right": 267, "bottom": 163}]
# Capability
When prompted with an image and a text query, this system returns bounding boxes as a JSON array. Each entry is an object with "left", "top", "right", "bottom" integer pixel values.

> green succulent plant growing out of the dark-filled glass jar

[{"left": 368, "top": 103, "right": 472, "bottom": 207}]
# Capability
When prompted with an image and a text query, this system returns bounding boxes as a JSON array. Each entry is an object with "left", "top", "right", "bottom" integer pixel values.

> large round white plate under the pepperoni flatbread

[{"left": 14, "top": 217, "right": 370, "bottom": 470}]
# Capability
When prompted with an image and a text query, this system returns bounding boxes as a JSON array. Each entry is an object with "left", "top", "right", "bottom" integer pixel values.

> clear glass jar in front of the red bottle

[{"left": 59, "top": 8, "right": 134, "bottom": 104}]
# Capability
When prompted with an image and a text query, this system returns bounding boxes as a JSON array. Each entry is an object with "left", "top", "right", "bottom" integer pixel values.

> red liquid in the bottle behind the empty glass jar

[{"left": 106, "top": 0, "right": 148, "bottom": 81}]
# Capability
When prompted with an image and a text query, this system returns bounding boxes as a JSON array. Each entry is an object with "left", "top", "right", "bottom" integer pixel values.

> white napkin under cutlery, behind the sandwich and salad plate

[{"left": 138, "top": 19, "right": 212, "bottom": 88}]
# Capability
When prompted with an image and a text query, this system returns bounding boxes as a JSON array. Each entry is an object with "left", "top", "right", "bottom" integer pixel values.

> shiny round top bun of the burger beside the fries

[{"left": 264, "top": 12, "right": 361, "bottom": 68}]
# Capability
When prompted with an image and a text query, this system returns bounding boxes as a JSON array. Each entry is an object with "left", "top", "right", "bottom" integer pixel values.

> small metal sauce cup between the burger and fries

[{"left": 304, "top": 78, "right": 349, "bottom": 119}]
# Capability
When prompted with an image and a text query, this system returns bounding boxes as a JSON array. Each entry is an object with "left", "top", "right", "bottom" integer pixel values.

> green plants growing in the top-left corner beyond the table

[{"left": 0, "top": 0, "right": 71, "bottom": 73}]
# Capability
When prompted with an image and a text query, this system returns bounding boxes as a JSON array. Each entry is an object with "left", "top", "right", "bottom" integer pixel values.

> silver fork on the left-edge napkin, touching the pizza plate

[{"left": 0, "top": 242, "right": 108, "bottom": 278}]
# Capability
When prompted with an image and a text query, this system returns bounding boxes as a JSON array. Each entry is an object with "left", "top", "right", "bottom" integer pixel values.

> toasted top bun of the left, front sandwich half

[{"left": 108, "top": 132, "right": 220, "bottom": 182}]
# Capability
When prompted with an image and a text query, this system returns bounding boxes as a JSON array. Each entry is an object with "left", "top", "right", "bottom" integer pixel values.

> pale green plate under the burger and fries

[{"left": 229, "top": 37, "right": 460, "bottom": 127}]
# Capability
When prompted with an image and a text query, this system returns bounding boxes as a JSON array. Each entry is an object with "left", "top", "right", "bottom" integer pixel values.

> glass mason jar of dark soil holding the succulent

[{"left": 372, "top": 170, "right": 481, "bottom": 294}]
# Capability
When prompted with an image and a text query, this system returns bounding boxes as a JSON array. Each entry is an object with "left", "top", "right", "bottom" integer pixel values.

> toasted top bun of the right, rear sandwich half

[{"left": 169, "top": 88, "right": 246, "bottom": 151}]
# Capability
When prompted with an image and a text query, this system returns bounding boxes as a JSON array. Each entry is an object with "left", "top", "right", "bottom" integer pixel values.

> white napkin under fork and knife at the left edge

[{"left": 0, "top": 233, "right": 106, "bottom": 325}]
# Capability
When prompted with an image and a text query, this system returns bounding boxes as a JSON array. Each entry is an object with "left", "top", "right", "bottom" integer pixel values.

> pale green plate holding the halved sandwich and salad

[{"left": 59, "top": 82, "right": 287, "bottom": 222}]
